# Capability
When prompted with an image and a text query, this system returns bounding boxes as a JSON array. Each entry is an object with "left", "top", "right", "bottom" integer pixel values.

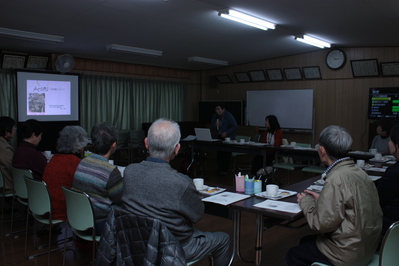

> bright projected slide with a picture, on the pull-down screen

[{"left": 26, "top": 80, "right": 71, "bottom": 115}]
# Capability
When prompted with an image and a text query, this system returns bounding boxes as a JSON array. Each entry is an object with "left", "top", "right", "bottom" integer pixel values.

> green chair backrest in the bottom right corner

[{"left": 379, "top": 222, "right": 399, "bottom": 266}]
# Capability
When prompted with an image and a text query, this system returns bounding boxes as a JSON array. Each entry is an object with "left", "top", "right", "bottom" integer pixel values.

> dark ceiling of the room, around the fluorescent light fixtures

[{"left": 0, "top": 0, "right": 399, "bottom": 70}]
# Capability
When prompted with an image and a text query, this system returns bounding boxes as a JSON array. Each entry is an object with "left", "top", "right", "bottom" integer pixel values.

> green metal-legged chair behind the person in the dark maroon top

[{"left": 10, "top": 167, "right": 33, "bottom": 238}]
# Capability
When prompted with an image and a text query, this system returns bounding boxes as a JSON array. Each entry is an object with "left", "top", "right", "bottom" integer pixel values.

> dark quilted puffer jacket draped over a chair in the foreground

[{"left": 96, "top": 207, "right": 186, "bottom": 266}]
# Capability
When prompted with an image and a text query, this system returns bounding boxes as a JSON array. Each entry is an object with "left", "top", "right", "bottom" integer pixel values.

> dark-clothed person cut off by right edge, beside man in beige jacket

[{"left": 377, "top": 122, "right": 399, "bottom": 235}]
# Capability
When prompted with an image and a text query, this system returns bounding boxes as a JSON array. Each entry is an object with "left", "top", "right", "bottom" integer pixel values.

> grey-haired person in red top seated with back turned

[{"left": 43, "top": 126, "right": 87, "bottom": 221}]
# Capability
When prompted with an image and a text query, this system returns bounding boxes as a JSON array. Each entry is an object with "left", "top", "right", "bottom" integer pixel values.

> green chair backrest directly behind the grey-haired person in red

[{"left": 24, "top": 176, "right": 51, "bottom": 215}]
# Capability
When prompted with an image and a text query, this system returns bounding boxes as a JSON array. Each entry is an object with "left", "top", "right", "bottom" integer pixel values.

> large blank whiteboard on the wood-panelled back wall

[{"left": 246, "top": 89, "right": 313, "bottom": 129}]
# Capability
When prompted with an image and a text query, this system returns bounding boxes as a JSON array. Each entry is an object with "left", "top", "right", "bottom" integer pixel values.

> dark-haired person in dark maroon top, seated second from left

[{"left": 12, "top": 119, "right": 47, "bottom": 180}]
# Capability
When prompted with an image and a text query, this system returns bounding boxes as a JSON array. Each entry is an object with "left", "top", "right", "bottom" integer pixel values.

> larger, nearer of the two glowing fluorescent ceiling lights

[{"left": 218, "top": 9, "right": 276, "bottom": 30}]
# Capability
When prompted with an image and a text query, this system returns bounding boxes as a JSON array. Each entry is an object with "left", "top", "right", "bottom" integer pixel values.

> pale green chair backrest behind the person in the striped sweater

[{"left": 62, "top": 186, "right": 95, "bottom": 231}]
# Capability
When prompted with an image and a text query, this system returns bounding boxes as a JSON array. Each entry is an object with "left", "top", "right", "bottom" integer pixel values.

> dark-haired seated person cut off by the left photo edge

[{"left": 0, "top": 116, "right": 16, "bottom": 189}]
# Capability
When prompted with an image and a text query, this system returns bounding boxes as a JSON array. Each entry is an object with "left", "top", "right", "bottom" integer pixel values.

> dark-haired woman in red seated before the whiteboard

[{"left": 251, "top": 115, "right": 283, "bottom": 175}]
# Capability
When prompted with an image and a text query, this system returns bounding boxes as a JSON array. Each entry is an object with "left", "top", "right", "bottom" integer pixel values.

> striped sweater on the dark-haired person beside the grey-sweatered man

[{"left": 72, "top": 153, "right": 123, "bottom": 223}]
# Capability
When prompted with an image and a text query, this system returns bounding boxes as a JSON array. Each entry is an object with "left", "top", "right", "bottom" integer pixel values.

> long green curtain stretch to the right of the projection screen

[{"left": 80, "top": 75, "right": 187, "bottom": 132}]
